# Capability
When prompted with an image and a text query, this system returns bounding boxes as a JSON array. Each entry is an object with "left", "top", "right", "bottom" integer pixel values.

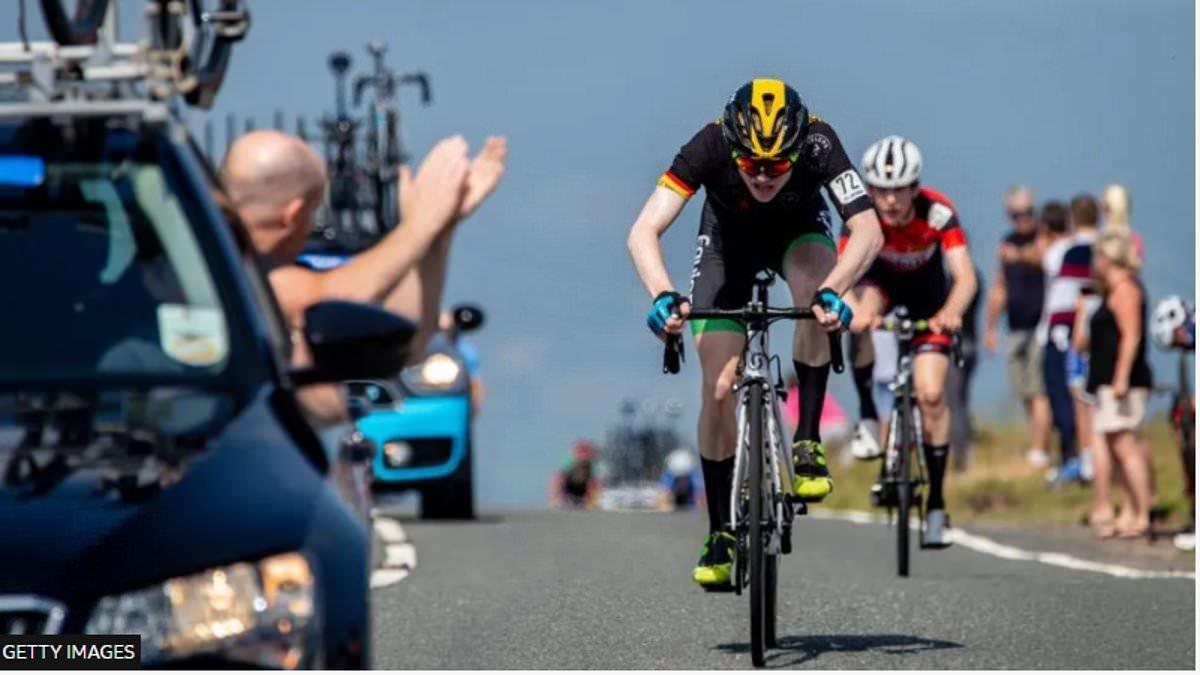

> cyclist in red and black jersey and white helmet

[{"left": 851, "top": 136, "right": 977, "bottom": 546}]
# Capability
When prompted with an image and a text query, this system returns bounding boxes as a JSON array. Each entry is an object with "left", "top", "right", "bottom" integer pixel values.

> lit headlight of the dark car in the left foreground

[{"left": 85, "top": 552, "right": 317, "bottom": 668}]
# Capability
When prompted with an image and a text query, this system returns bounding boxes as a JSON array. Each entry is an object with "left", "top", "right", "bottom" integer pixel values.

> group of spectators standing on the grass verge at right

[{"left": 984, "top": 185, "right": 1194, "bottom": 548}]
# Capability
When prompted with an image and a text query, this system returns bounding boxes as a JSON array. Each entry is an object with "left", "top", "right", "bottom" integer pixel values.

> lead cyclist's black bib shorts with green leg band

[{"left": 689, "top": 197, "right": 836, "bottom": 335}]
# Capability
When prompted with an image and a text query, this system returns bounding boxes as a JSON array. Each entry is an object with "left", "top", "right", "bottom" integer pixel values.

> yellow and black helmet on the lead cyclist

[{"left": 721, "top": 78, "right": 809, "bottom": 160}]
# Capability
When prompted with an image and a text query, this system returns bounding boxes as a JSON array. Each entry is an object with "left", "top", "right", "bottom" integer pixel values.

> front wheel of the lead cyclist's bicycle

[{"left": 746, "top": 383, "right": 774, "bottom": 668}]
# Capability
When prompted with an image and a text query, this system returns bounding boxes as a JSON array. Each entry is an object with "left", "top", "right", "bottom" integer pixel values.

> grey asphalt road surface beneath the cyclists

[{"left": 373, "top": 512, "right": 1196, "bottom": 670}]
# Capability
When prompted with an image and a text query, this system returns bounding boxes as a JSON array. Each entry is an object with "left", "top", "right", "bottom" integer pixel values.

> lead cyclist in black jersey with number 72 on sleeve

[{"left": 629, "top": 78, "right": 883, "bottom": 587}]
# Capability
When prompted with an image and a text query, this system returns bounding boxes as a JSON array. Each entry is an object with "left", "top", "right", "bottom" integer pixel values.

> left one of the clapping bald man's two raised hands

[{"left": 400, "top": 136, "right": 470, "bottom": 234}]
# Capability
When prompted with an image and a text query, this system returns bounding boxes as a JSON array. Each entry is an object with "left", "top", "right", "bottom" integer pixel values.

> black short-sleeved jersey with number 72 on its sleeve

[{"left": 659, "top": 117, "right": 871, "bottom": 223}]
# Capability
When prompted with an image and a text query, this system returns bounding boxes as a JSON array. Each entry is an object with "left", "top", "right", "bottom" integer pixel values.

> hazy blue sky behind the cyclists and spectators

[{"left": 7, "top": 0, "right": 1195, "bottom": 504}]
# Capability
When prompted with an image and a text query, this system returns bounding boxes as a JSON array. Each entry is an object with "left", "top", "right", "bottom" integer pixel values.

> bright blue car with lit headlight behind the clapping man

[{"left": 347, "top": 305, "right": 484, "bottom": 519}]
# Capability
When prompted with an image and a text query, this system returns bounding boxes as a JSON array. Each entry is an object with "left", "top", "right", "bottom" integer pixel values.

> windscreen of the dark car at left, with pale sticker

[{"left": 0, "top": 120, "right": 229, "bottom": 381}]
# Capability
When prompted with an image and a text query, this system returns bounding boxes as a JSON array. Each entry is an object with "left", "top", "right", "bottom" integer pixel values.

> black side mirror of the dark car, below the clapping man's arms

[{"left": 292, "top": 300, "right": 416, "bottom": 386}]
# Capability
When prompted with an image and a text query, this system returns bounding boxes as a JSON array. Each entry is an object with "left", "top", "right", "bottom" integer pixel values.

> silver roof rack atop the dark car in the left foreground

[{"left": 0, "top": 0, "right": 250, "bottom": 121}]
